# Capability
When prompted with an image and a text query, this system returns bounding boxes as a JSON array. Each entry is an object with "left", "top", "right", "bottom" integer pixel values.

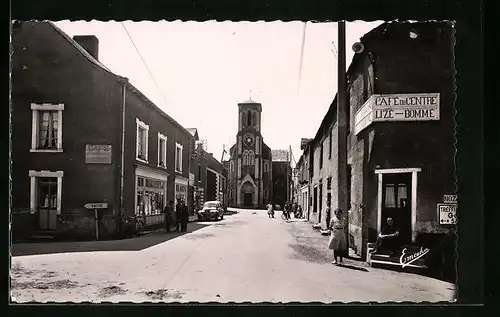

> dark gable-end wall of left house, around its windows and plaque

[{"left": 11, "top": 22, "right": 121, "bottom": 236}]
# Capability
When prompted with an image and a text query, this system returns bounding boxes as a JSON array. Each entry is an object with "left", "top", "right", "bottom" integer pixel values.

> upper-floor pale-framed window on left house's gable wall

[{"left": 30, "top": 103, "right": 64, "bottom": 152}]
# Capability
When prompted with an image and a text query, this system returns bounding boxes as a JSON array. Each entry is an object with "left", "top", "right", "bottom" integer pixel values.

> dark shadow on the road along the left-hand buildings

[{"left": 11, "top": 222, "right": 209, "bottom": 256}]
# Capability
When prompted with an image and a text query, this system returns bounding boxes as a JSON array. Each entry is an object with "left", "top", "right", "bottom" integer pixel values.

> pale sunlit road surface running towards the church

[{"left": 12, "top": 210, "right": 454, "bottom": 303}]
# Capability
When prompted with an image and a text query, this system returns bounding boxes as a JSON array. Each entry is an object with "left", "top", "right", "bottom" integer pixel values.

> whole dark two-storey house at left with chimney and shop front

[{"left": 11, "top": 22, "right": 194, "bottom": 239}]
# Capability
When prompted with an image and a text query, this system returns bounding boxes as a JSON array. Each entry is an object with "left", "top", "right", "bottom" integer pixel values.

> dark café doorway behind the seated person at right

[{"left": 382, "top": 173, "right": 411, "bottom": 244}]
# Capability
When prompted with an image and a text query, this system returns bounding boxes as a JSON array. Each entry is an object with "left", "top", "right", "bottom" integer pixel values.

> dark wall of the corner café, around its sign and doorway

[{"left": 349, "top": 23, "right": 456, "bottom": 252}]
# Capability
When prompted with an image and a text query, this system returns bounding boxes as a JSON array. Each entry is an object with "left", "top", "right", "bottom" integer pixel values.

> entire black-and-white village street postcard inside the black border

[{"left": 10, "top": 21, "right": 458, "bottom": 303}]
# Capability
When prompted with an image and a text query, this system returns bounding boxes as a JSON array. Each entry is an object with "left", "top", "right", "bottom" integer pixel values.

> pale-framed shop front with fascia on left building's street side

[{"left": 135, "top": 167, "right": 168, "bottom": 226}]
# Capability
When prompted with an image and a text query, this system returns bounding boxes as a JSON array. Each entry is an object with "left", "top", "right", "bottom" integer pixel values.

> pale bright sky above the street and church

[{"left": 55, "top": 20, "right": 382, "bottom": 164}]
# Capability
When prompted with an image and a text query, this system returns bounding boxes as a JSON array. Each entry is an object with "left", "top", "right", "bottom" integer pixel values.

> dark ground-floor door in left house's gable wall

[{"left": 38, "top": 177, "right": 57, "bottom": 230}]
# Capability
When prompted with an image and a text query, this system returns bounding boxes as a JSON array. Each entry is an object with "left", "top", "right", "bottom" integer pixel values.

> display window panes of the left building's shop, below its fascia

[{"left": 136, "top": 176, "right": 167, "bottom": 216}]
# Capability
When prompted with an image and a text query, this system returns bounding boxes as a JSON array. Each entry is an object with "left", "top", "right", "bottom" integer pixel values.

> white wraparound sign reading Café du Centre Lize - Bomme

[{"left": 354, "top": 93, "right": 439, "bottom": 134}]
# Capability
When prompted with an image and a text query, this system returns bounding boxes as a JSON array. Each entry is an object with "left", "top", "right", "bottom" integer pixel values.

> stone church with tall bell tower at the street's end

[{"left": 224, "top": 100, "right": 273, "bottom": 208}]
